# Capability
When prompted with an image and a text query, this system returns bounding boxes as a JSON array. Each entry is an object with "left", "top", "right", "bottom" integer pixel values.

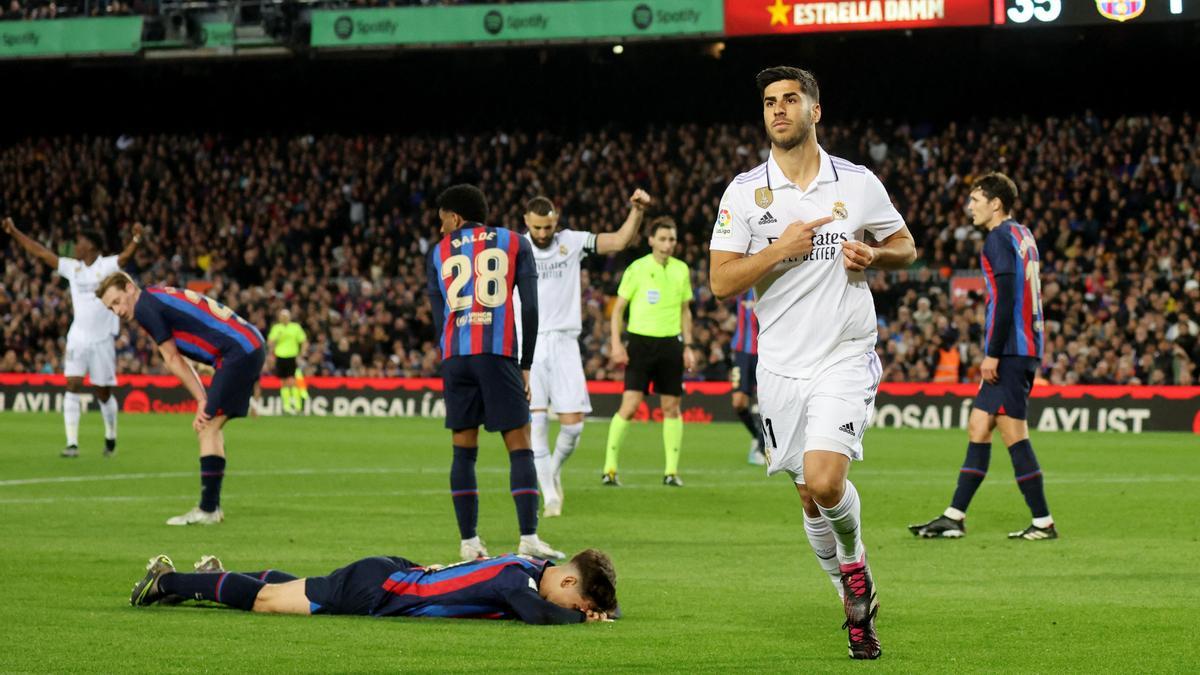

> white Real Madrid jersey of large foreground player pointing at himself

[{"left": 709, "top": 148, "right": 904, "bottom": 380}]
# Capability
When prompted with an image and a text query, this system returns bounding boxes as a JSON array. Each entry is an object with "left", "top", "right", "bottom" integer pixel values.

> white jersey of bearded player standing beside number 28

[{"left": 526, "top": 229, "right": 596, "bottom": 333}]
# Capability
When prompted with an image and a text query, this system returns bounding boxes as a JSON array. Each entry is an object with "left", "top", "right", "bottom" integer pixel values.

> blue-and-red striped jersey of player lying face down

[{"left": 371, "top": 554, "right": 584, "bottom": 623}]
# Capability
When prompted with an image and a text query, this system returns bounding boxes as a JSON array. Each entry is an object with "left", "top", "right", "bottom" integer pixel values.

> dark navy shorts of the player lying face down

[{"left": 304, "top": 556, "right": 420, "bottom": 616}]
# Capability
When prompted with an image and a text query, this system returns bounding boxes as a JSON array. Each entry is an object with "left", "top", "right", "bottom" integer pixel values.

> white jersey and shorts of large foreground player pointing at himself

[{"left": 709, "top": 149, "right": 904, "bottom": 483}]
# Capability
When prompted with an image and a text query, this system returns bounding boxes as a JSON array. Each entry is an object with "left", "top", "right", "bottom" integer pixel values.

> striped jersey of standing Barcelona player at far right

[{"left": 982, "top": 220, "right": 1043, "bottom": 359}]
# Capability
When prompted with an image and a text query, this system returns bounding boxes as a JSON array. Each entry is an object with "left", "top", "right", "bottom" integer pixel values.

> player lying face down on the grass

[{"left": 130, "top": 549, "right": 617, "bottom": 625}]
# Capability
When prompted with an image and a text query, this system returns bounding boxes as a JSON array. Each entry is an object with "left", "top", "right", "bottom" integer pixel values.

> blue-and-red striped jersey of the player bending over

[{"left": 133, "top": 286, "right": 263, "bottom": 366}]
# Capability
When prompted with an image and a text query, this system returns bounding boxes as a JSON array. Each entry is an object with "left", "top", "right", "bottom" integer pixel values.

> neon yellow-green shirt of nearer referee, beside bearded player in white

[{"left": 617, "top": 253, "right": 691, "bottom": 338}]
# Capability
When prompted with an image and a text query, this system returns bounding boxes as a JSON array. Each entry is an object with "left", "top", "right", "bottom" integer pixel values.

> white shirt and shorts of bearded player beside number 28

[{"left": 517, "top": 229, "right": 596, "bottom": 413}]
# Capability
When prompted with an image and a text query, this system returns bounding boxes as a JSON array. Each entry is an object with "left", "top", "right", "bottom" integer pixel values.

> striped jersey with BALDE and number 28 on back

[{"left": 427, "top": 223, "right": 538, "bottom": 368}]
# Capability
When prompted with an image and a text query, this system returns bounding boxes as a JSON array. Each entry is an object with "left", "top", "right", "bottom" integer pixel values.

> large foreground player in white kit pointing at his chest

[{"left": 709, "top": 66, "right": 916, "bottom": 658}]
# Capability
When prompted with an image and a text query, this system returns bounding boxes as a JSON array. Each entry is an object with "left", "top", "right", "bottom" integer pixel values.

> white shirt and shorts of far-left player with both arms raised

[{"left": 58, "top": 256, "right": 120, "bottom": 387}]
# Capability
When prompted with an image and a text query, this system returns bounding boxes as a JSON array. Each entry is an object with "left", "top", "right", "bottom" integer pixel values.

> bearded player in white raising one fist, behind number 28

[{"left": 524, "top": 190, "right": 650, "bottom": 518}]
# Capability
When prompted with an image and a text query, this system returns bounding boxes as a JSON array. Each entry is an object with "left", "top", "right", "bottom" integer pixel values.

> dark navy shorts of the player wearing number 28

[{"left": 442, "top": 354, "right": 529, "bottom": 431}]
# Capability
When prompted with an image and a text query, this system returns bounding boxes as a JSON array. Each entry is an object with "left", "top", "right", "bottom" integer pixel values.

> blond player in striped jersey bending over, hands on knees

[{"left": 96, "top": 271, "right": 265, "bottom": 525}]
